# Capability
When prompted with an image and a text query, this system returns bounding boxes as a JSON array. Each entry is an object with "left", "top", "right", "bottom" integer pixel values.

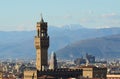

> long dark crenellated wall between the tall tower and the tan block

[{"left": 38, "top": 69, "right": 83, "bottom": 78}]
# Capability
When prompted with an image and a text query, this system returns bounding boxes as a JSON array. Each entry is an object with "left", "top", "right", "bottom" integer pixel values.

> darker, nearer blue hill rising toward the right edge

[{"left": 57, "top": 34, "right": 120, "bottom": 59}]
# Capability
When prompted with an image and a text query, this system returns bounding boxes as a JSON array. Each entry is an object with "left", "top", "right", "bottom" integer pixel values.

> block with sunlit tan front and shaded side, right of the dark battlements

[{"left": 80, "top": 66, "right": 107, "bottom": 79}]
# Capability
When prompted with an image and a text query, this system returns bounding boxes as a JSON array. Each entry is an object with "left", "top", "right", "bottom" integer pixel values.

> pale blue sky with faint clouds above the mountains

[{"left": 0, "top": 0, "right": 120, "bottom": 30}]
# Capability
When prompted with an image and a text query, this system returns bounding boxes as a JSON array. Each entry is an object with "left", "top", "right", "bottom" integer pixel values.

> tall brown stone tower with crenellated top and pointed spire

[{"left": 35, "top": 16, "right": 49, "bottom": 71}]
